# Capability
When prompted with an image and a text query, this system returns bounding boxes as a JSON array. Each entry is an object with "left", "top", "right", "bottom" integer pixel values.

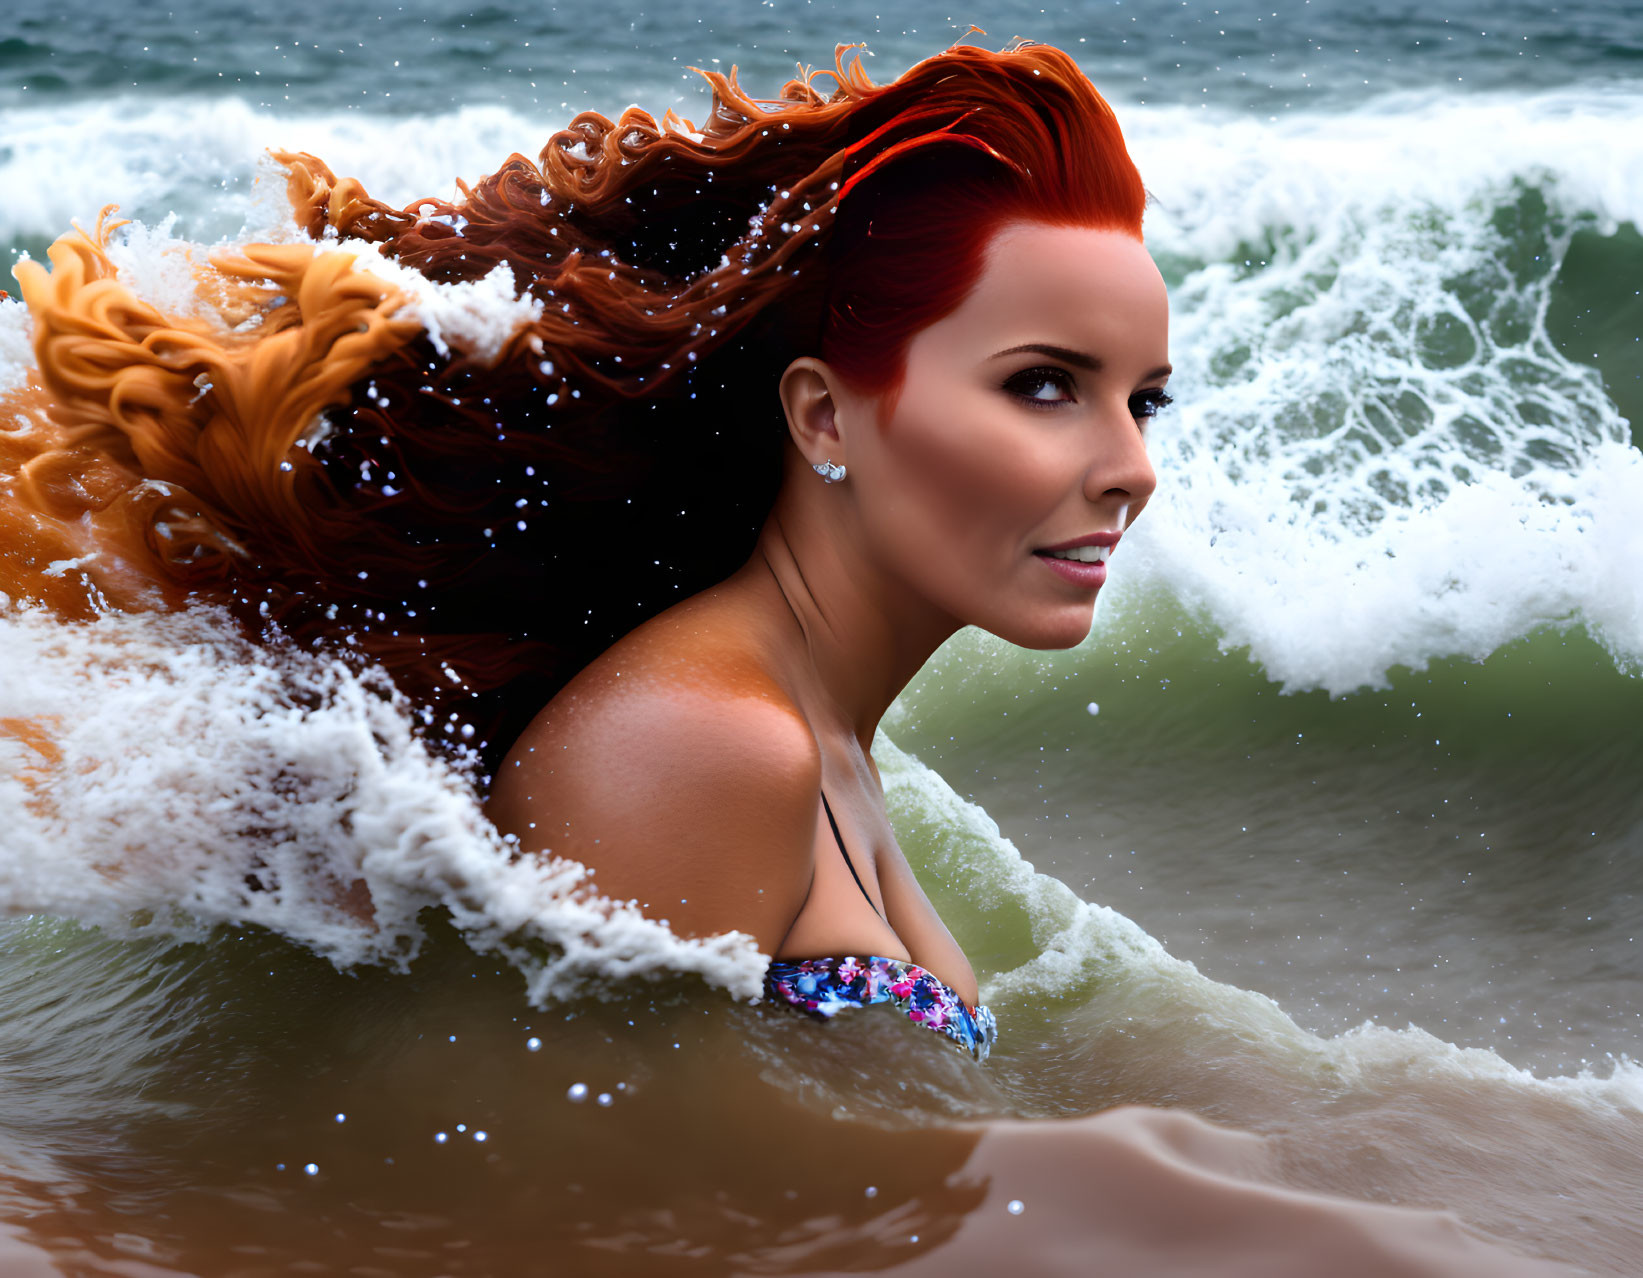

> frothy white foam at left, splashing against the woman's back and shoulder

[{"left": 0, "top": 609, "right": 764, "bottom": 1002}]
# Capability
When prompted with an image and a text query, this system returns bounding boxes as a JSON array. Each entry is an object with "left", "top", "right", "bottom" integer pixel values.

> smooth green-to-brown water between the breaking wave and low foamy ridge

[{"left": 891, "top": 598, "right": 1643, "bottom": 1073}]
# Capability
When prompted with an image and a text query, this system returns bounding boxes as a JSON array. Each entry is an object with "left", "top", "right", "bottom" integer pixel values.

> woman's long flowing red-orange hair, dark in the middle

[{"left": 0, "top": 34, "right": 1145, "bottom": 761}]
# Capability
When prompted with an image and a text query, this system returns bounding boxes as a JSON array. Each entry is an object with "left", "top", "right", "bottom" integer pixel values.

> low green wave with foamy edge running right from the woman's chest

[{"left": 874, "top": 734, "right": 1643, "bottom": 1112}]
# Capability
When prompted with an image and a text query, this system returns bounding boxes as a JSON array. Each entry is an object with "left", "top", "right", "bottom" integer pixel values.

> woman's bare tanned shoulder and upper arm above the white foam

[{"left": 486, "top": 591, "right": 822, "bottom": 953}]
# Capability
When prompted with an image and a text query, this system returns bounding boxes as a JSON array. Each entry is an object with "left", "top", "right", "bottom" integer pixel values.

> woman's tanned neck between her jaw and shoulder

[{"left": 744, "top": 467, "right": 960, "bottom": 752}]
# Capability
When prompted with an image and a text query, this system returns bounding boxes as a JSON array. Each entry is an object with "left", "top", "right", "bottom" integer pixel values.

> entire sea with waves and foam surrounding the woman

[{"left": 0, "top": 0, "right": 1643, "bottom": 1275}]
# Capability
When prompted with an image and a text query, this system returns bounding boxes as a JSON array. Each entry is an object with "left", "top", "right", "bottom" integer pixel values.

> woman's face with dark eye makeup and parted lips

[{"left": 845, "top": 222, "right": 1170, "bottom": 647}]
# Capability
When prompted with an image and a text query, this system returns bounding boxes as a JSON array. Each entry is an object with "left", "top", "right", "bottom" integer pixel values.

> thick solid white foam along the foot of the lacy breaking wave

[{"left": 1127, "top": 444, "right": 1643, "bottom": 695}]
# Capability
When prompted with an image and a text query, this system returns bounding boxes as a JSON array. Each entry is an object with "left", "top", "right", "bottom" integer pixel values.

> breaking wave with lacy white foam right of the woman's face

[{"left": 1117, "top": 90, "right": 1643, "bottom": 693}]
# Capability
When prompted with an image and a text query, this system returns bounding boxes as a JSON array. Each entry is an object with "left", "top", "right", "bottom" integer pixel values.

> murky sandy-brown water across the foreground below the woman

[{"left": 0, "top": 923, "right": 1623, "bottom": 1275}]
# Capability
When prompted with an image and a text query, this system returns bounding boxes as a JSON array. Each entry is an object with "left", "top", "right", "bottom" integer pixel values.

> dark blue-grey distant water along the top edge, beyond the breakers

[{"left": 0, "top": 0, "right": 1643, "bottom": 118}]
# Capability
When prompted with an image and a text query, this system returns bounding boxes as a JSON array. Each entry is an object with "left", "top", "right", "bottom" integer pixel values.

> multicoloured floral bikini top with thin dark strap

[{"left": 764, "top": 795, "right": 999, "bottom": 1061}]
